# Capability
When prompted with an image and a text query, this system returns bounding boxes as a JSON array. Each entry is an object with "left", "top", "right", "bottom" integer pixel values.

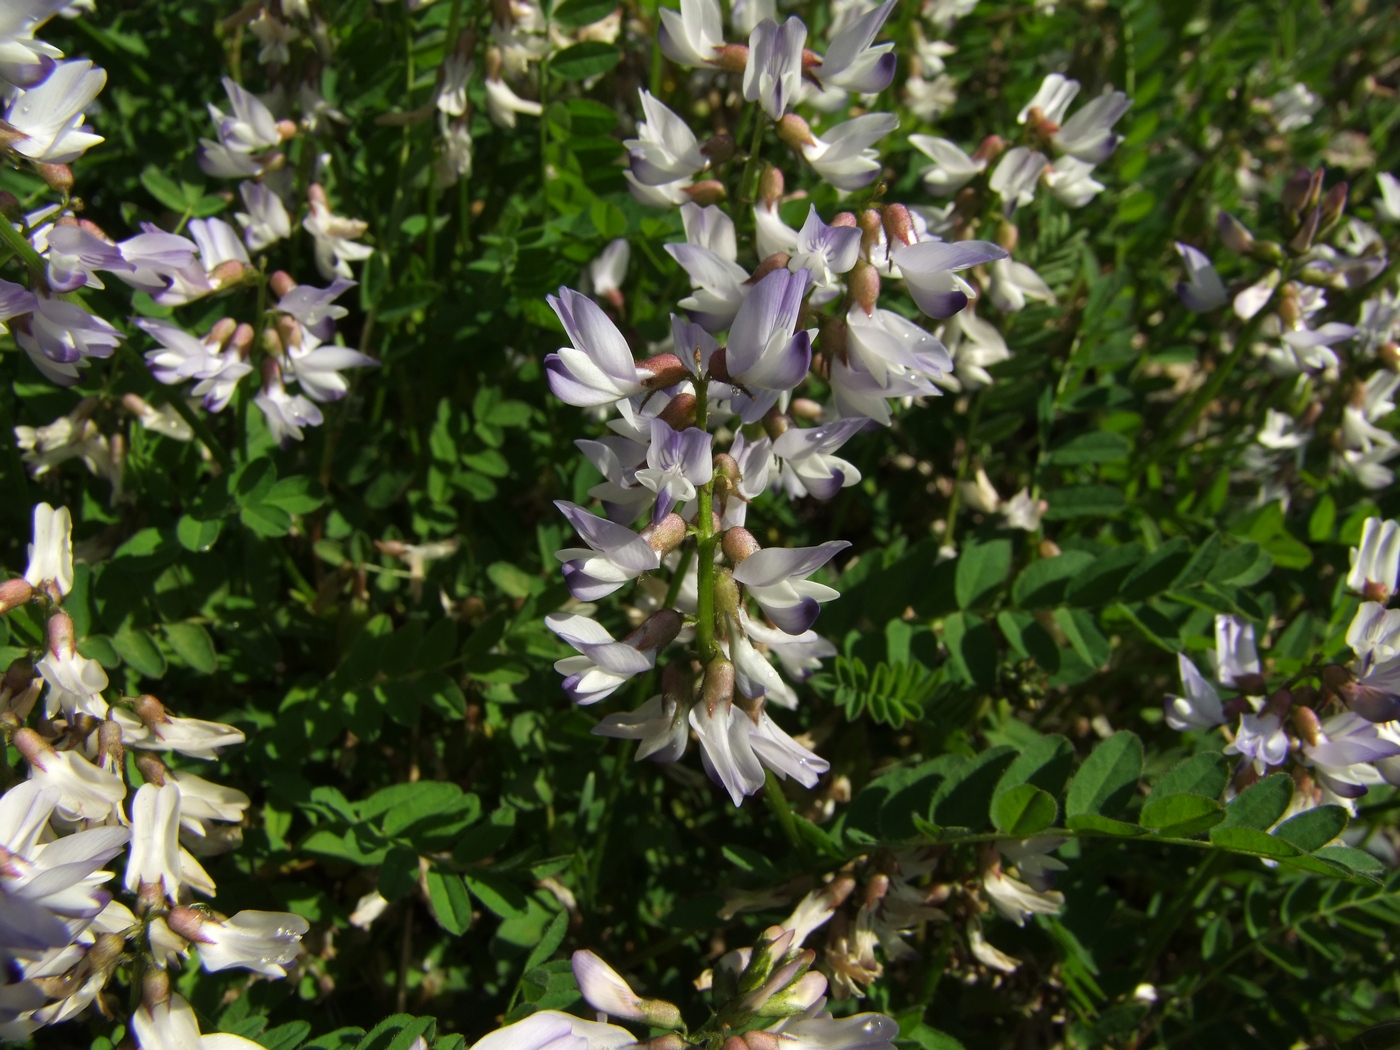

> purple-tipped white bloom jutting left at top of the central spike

[{"left": 545, "top": 288, "right": 645, "bottom": 407}]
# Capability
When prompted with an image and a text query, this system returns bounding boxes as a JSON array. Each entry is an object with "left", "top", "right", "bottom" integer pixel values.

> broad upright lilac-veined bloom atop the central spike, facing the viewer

[{"left": 725, "top": 270, "right": 812, "bottom": 423}]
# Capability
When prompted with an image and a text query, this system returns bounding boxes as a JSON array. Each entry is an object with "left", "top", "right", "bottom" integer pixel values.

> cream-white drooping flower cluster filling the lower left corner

[{"left": 0, "top": 504, "right": 309, "bottom": 1050}]
